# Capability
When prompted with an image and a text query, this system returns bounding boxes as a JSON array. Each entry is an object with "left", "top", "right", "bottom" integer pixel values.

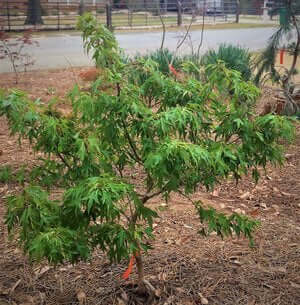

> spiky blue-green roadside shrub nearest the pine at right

[{"left": 201, "top": 44, "right": 252, "bottom": 81}]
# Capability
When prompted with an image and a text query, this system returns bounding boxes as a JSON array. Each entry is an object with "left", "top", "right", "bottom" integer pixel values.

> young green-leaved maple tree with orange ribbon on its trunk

[{"left": 0, "top": 15, "right": 293, "bottom": 290}]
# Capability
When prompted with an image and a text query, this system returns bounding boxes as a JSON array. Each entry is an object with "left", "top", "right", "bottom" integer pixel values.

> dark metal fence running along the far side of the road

[{"left": 0, "top": 0, "right": 278, "bottom": 31}]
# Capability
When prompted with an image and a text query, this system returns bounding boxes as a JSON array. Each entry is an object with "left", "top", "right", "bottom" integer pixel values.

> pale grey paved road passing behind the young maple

[{"left": 0, "top": 28, "right": 274, "bottom": 72}]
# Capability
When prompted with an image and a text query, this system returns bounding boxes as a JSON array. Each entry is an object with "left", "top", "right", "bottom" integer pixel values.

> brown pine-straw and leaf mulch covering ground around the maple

[{"left": 0, "top": 69, "right": 300, "bottom": 305}]
